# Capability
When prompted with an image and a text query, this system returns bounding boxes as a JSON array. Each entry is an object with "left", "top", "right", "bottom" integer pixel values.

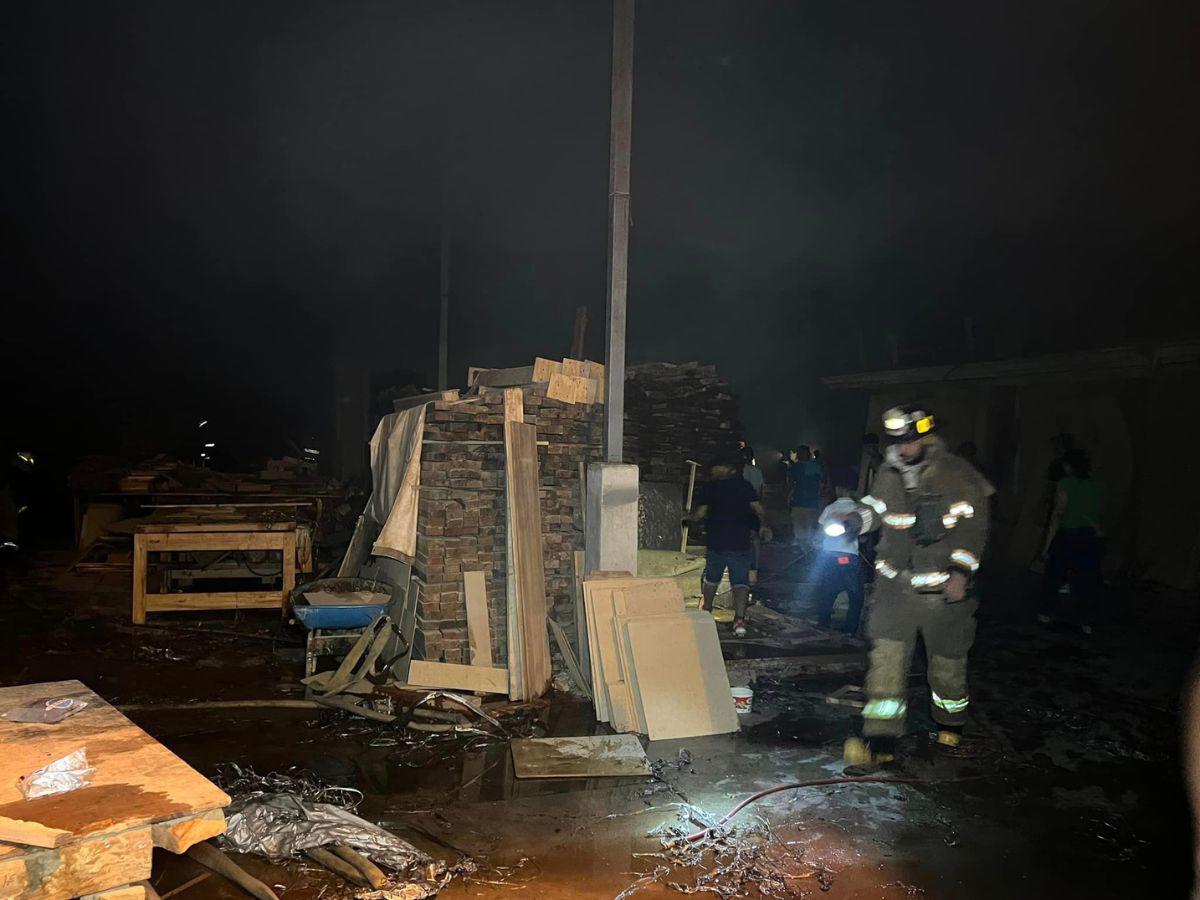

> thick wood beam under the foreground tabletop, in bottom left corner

[{"left": 0, "top": 830, "right": 154, "bottom": 900}]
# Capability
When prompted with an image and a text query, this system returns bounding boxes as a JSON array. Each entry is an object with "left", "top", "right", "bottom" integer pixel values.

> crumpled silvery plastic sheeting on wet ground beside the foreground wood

[{"left": 223, "top": 793, "right": 462, "bottom": 898}]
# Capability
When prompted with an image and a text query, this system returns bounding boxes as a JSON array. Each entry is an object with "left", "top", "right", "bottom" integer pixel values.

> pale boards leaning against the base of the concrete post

[{"left": 583, "top": 577, "right": 738, "bottom": 740}]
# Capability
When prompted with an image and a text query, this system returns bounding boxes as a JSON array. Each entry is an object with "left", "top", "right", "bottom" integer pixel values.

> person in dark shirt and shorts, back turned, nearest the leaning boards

[{"left": 692, "top": 456, "right": 770, "bottom": 637}]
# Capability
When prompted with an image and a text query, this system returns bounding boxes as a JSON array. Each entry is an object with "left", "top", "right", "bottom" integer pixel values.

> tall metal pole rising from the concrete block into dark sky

[{"left": 604, "top": 0, "right": 634, "bottom": 462}]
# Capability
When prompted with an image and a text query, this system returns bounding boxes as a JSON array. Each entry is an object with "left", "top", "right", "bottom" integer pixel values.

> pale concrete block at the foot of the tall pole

[{"left": 583, "top": 462, "right": 637, "bottom": 575}]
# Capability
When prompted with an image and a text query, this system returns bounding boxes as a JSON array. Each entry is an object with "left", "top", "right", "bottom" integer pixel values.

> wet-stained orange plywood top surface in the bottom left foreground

[{"left": 0, "top": 682, "right": 229, "bottom": 844}]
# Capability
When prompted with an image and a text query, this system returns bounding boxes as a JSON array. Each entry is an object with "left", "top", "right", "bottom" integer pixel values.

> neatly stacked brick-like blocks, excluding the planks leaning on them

[{"left": 414, "top": 384, "right": 604, "bottom": 671}]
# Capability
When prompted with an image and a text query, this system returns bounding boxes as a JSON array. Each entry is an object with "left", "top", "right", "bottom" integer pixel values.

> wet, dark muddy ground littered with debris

[{"left": 0, "top": 550, "right": 1198, "bottom": 900}]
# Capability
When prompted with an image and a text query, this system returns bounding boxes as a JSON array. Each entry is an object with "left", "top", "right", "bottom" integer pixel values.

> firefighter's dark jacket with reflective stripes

[{"left": 859, "top": 434, "right": 992, "bottom": 594}]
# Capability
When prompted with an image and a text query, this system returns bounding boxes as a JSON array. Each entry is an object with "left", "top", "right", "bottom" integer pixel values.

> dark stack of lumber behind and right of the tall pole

[{"left": 625, "top": 362, "right": 742, "bottom": 484}]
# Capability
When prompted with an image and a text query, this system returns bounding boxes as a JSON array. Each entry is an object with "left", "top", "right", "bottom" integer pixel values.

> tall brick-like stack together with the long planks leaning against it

[{"left": 409, "top": 382, "right": 602, "bottom": 700}]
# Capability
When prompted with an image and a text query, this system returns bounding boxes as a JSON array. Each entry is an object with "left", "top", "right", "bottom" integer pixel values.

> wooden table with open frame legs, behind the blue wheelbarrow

[{"left": 133, "top": 515, "right": 301, "bottom": 625}]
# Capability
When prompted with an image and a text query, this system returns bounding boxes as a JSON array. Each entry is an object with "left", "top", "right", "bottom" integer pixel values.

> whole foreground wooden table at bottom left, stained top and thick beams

[{"left": 0, "top": 682, "right": 229, "bottom": 900}]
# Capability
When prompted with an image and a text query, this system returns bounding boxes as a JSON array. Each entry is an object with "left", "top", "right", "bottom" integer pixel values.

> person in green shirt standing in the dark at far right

[{"left": 1038, "top": 448, "right": 1105, "bottom": 635}]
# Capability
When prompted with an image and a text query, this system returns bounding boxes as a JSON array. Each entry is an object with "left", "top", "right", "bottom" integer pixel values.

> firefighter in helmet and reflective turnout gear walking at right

[{"left": 845, "top": 407, "right": 991, "bottom": 767}]
